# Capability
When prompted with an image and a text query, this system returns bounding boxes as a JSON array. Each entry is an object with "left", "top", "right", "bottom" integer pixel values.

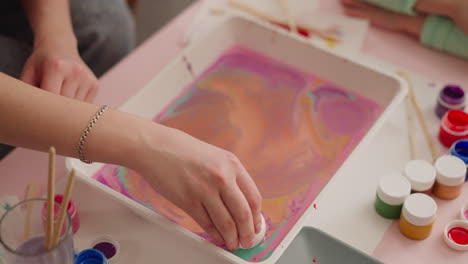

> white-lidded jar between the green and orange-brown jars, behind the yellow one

[{"left": 403, "top": 160, "right": 436, "bottom": 194}]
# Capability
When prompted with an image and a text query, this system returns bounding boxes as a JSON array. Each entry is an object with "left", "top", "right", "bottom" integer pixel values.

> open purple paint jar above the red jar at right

[{"left": 435, "top": 85, "right": 465, "bottom": 118}]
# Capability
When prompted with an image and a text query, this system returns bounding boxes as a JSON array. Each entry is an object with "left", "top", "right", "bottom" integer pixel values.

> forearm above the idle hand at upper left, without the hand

[{"left": 22, "top": 0, "right": 76, "bottom": 46}]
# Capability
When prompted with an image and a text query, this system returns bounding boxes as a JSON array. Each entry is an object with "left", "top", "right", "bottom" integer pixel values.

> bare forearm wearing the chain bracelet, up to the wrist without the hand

[{"left": 0, "top": 73, "right": 157, "bottom": 167}]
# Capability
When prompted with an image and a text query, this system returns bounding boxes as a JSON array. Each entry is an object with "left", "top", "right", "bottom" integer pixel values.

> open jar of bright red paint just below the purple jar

[{"left": 439, "top": 110, "right": 468, "bottom": 148}]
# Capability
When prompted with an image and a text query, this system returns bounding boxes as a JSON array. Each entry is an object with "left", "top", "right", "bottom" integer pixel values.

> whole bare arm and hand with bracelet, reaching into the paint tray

[{"left": 0, "top": 73, "right": 262, "bottom": 250}]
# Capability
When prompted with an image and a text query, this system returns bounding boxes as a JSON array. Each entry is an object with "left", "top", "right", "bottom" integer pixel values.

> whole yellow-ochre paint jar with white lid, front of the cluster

[{"left": 400, "top": 193, "right": 437, "bottom": 240}]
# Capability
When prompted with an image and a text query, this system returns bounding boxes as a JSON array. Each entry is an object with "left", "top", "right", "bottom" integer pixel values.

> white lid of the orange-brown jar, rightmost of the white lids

[{"left": 434, "top": 155, "right": 466, "bottom": 186}]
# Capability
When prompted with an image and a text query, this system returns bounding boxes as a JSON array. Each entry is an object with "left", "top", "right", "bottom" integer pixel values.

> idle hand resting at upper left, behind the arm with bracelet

[{"left": 20, "top": 38, "right": 99, "bottom": 102}]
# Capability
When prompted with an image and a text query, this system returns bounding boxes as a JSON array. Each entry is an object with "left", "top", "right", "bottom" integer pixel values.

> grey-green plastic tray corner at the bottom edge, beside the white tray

[{"left": 277, "top": 227, "right": 383, "bottom": 264}]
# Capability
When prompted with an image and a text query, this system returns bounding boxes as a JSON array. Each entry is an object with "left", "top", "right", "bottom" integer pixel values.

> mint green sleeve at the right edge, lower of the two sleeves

[{"left": 420, "top": 15, "right": 468, "bottom": 59}]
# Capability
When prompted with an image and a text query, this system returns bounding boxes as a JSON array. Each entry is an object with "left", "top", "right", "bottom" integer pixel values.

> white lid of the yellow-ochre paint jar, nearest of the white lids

[{"left": 402, "top": 193, "right": 437, "bottom": 226}]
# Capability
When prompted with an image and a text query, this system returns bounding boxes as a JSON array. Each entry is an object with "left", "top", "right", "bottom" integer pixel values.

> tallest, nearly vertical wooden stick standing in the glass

[{"left": 46, "top": 147, "right": 55, "bottom": 249}]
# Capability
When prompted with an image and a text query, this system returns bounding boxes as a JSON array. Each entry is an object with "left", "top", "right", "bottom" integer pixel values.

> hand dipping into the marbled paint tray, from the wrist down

[{"left": 136, "top": 125, "right": 261, "bottom": 250}]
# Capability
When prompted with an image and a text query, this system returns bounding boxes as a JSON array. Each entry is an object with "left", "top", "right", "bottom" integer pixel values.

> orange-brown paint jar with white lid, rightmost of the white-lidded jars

[{"left": 432, "top": 155, "right": 466, "bottom": 200}]
